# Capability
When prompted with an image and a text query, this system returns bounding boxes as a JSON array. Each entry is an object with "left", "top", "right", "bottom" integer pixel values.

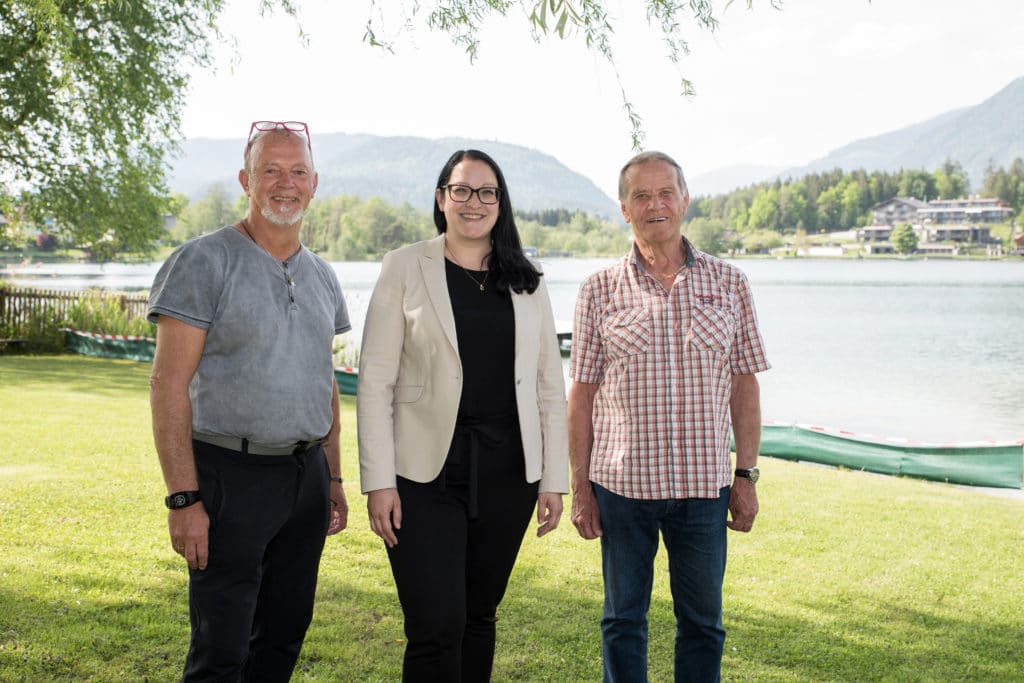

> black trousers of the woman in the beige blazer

[{"left": 388, "top": 426, "right": 538, "bottom": 683}]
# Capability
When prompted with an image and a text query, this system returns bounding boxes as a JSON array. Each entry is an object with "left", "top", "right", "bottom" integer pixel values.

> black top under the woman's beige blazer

[{"left": 444, "top": 259, "right": 517, "bottom": 422}]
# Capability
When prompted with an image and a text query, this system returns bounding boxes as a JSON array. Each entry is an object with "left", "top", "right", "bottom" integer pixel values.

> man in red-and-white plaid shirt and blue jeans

[{"left": 568, "top": 152, "right": 770, "bottom": 682}]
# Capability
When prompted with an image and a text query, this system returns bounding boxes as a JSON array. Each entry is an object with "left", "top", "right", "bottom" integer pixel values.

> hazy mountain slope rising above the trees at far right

[{"left": 690, "top": 77, "right": 1024, "bottom": 196}]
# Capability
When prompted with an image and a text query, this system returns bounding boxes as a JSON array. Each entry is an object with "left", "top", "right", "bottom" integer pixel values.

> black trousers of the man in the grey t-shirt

[{"left": 182, "top": 441, "right": 331, "bottom": 683}]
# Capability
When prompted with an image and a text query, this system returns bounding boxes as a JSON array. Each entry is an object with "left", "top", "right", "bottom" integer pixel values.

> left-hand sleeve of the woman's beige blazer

[{"left": 355, "top": 254, "right": 406, "bottom": 494}]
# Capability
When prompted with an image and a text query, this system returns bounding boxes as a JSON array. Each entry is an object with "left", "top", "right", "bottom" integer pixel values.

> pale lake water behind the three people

[{"left": 0, "top": 259, "right": 1024, "bottom": 441}]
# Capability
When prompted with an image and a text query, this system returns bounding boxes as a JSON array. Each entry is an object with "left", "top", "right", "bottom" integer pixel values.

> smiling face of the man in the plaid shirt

[{"left": 621, "top": 160, "right": 690, "bottom": 245}]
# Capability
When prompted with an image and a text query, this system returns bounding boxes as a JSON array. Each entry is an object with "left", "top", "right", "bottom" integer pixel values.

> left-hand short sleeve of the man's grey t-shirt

[{"left": 146, "top": 240, "right": 224, "bottom": 330}]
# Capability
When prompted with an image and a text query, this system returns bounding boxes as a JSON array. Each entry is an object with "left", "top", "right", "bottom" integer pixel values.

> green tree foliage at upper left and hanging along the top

[{"left": 0, "top": 0, "right": 780, "bottom": 259}]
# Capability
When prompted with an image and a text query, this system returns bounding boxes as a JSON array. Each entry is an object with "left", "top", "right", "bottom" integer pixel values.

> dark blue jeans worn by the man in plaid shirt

[{"left": 594, "top": 484, "right": 729, "bottom": 683}]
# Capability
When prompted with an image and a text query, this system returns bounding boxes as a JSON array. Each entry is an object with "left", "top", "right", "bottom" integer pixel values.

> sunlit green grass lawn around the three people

[{"left": 0, "top": 355, "right": 1024, "bottom": 682}]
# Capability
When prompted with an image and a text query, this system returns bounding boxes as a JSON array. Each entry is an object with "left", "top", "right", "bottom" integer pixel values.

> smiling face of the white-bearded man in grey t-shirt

[{"left": 239, "top": 132, "right": 317, "bottom": 226}]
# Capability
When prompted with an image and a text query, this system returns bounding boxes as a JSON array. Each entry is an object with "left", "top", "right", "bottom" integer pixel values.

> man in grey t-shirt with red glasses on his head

[{"left": 150, "top": 121, "right": 351, "bottom": 681}]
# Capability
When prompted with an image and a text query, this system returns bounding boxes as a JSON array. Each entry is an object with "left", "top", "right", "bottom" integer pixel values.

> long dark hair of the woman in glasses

[{"left": 434, "top": 150, "right": 543, "bottom": 294}]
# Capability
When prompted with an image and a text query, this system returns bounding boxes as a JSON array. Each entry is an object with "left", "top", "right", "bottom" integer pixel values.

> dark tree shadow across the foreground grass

[{"left": 0, "top": 559, "right": 1021, "bottom": 681}]
